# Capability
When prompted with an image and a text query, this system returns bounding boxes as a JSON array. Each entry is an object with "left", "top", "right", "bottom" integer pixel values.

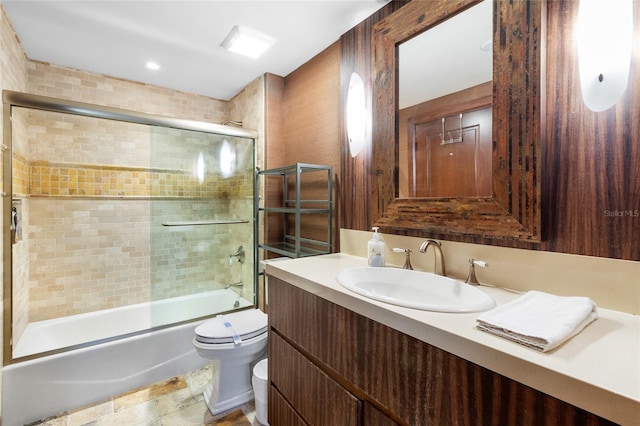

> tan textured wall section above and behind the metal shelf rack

[{"left": 265, "top": 42, "right": 341, "bottom": 251}]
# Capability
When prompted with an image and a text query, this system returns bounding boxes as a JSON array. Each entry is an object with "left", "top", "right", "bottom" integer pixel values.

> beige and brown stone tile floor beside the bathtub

[{"left": 29, "top": 366, "right": 259, "bottom": 426}]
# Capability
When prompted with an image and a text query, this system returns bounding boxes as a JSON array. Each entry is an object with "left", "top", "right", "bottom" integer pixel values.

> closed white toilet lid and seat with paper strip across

[{"left": 196, "top": 309, "right": 268, "bottom": 344}]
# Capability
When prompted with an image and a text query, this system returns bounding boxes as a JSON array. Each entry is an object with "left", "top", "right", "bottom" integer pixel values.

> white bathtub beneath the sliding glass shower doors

[{"left": 2, "top": 289, "right": 252, "bottom": 426}]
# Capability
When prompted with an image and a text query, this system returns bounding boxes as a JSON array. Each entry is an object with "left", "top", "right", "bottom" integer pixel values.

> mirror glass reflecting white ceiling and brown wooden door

[{"left": 398, "top": 0, "right": 493, "bottom": 198}]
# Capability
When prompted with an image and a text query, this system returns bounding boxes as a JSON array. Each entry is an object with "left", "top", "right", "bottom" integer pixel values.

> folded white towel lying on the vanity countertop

[{"left": 477, "top": 291, "right": 598, "bottom": 352}]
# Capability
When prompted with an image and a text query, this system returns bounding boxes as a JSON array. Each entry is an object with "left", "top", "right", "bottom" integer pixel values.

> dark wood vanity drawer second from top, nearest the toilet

[{"left": 269, "top": 332, "right": 360, "bottom": 426}]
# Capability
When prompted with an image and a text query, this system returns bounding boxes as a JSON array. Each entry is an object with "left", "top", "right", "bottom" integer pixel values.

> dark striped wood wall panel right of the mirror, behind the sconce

[{"left": 543, "top": 1, "right": 640, "bottom": 260}]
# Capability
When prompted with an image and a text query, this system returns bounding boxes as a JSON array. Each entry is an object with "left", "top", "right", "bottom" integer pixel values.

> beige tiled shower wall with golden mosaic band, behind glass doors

[{"left": 14, "top": 111, "right": 253, "bottom": 324}]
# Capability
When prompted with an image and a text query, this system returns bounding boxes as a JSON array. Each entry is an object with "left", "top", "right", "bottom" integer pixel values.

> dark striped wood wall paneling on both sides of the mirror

[{"left": 341, "top": 1, "right": 640, "bottom": 261}]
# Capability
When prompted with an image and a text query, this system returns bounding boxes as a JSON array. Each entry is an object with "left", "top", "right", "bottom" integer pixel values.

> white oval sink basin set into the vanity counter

[{"left": 336, "top": 267, "right": 496, "bottom": 312}]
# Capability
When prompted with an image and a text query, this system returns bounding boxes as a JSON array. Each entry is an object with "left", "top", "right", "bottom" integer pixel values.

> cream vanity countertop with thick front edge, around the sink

[{"left": 266, "top": 253, "right": 640, "bottom": 425}]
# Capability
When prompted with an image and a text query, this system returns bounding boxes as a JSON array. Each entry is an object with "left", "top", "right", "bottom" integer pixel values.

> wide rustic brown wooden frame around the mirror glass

[{"left": 370, "top": 0, "right": 545, "bottom": 243}]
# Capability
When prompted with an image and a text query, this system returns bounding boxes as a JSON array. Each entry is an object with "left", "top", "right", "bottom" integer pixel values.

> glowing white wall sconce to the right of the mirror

[{"left": 577, "top": 0, "right": 633, "bottom": 111}]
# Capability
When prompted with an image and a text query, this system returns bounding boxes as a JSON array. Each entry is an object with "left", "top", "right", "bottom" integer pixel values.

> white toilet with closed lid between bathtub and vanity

[{"left": 193, "top": 309, "right": 268, "bottom": 415}]
